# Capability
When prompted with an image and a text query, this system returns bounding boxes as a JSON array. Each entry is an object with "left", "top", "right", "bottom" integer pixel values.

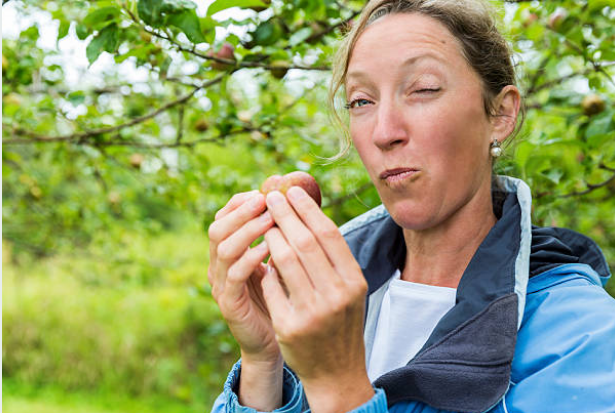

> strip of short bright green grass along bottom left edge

[{"left": 2, "top": 379, "right": 209, "bottom": 413}]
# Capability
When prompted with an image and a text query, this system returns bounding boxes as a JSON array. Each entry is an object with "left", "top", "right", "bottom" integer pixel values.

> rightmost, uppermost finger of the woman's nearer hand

[{"left": 286, "top": 186, "right": 362, "bottom": 281}]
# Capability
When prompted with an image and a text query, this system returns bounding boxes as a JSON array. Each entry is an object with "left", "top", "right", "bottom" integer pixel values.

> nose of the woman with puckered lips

[{"left": 372, "top": 101, "right": 408, "bottom": 150}]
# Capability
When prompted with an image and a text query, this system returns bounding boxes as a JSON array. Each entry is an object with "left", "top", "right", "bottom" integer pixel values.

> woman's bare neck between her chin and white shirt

[{"left": 401, "top": 183, "right": 497, "bottom": 288}]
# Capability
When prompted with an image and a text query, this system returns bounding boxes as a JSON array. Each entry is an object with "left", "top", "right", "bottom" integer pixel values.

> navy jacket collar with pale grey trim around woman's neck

[{"left": 341, "top": 177, "right": 532, "bottom": 412}]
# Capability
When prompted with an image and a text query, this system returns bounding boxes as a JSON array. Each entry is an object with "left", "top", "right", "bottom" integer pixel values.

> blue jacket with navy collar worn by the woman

[{"left": 213, "top": 177, "right": 615, "bottom": 413}]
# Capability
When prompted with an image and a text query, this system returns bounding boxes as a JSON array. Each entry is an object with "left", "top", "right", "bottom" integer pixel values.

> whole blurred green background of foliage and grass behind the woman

[{"left": 2, "top": 0, "right": 615, "bottom": 413}]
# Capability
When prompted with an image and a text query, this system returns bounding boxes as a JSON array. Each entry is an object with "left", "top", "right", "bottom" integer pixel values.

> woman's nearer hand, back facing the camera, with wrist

[{"left": 262, "top": 187, "right": 374, "bottom": 413}]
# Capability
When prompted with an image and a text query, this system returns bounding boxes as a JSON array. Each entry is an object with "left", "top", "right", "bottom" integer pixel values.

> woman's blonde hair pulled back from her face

[{"left": 329, "top": 0, "right": 524, "bottom": 159}]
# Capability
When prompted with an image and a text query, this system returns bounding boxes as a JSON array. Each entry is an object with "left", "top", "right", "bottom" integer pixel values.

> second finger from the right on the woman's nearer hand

[{"left": 267, "top": 191, "right": 337, "bottom": 290}]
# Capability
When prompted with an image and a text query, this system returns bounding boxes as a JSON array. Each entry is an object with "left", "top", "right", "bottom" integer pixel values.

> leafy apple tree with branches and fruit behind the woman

[{"left": 2, "top": 0, "right": 615, "bottom": 292}]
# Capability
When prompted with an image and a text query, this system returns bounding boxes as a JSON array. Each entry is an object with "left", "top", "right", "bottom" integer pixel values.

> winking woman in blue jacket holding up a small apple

[{"left": 208, "top": 0, "right": 615, "bottom": 413}]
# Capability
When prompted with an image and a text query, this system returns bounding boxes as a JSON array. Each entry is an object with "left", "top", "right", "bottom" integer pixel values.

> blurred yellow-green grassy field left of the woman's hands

[{"left": 2, "top": 230, "right": 237, "bottom": 413}]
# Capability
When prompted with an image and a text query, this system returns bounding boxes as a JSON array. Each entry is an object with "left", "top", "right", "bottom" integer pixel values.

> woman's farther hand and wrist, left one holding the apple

[{"left": 207, "top": 191, "right": 283, "bottom": 411}]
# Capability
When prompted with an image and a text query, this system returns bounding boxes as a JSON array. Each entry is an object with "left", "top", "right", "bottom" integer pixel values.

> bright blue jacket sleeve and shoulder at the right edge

[{"left": 498, "top": 270, "right": 615, "bottom": 413}]
